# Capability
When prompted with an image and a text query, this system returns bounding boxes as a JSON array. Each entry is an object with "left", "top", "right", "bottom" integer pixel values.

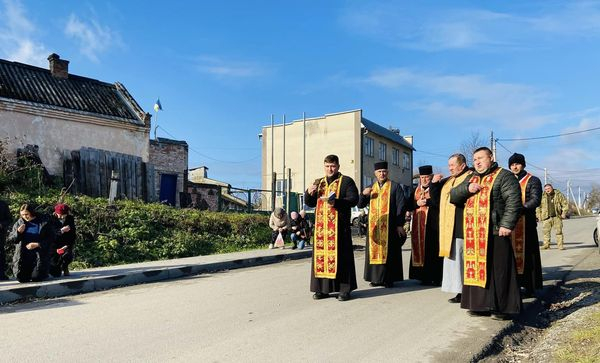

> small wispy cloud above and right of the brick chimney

[{"left": 64, "top": 14, "right": 122, "bottom": 62}]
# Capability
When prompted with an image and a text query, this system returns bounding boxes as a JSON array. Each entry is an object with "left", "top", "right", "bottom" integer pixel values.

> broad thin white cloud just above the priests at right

[{"left": 362, "top": 68, "right": 555, "bottom": 129}]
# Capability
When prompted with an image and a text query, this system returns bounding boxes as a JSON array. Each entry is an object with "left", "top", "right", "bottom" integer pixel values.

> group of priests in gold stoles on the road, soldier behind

[{"left": 304, "top": 151, "right": 568, "bottom": 320}]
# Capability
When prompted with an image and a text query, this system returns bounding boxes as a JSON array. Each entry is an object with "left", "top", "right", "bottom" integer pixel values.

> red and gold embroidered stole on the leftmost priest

[{"left": 313, "top": 174, "right": 342, "bottom": 279}]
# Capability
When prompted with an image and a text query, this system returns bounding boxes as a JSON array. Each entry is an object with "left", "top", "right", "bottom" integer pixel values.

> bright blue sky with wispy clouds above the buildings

[{"left": 0, "top": 0, "right": 600, "bottom": 199}]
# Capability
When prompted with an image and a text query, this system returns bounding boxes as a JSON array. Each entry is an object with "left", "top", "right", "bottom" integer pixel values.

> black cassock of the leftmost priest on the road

[{"left": 304, "top": 174, "right": 358, "bottom": 294}]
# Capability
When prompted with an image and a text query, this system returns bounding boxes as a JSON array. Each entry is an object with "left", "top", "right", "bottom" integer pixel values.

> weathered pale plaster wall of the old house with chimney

[{"left": 0, "top": 100, "right": 150, "bottom": 176}]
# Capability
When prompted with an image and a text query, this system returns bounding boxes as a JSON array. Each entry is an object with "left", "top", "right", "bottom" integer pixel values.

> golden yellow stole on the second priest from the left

[{"left": 369, "top": 180, "right": 392, "bottom": 265}]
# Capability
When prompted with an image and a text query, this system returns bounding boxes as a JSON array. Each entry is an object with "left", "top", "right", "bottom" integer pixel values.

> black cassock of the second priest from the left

[{"left": 358, "top": 181, "right": 406, "bottom": 285}]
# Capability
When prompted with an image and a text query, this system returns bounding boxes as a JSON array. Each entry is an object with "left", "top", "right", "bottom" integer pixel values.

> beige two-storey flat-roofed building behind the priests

[{"left": 260, "top": 110, "right": 415, "bottom": 205}]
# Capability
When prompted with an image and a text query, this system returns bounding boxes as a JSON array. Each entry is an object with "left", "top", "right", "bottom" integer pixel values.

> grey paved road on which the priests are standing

[{"left": 0, "top": 218, "right": 597, "bottom": 362}]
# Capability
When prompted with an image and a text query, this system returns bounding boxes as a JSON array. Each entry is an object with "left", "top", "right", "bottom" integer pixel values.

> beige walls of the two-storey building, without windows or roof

[{"left": 261, "top": 110, "right": 412, "bottom": 206}]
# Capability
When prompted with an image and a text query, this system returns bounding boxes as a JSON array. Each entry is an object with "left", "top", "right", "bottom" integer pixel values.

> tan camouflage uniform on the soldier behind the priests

[{"left": 535, "top": 189, "right": 569, "bottom": 250}]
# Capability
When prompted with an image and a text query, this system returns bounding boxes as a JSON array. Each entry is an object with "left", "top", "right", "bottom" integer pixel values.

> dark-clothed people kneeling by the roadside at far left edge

[{"left": 0, "top": 201, "right": 76, "bottom": 282}]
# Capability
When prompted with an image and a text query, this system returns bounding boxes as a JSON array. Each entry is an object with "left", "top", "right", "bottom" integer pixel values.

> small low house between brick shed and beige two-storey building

[{"left": 186, "top": 166, "right": 248, "bottom": 211}]
